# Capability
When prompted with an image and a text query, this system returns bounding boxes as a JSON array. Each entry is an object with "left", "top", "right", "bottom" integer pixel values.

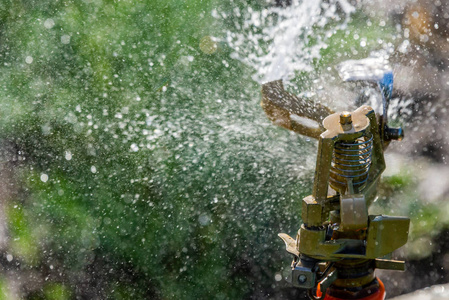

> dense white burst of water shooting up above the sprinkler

[{"left": 220, "top": 0, "right": 356, "bottom": 83}]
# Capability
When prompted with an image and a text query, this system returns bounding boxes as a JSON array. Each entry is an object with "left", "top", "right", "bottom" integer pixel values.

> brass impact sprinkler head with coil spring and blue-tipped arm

[{"left": 262, "top": 59, "right": 410, "bottom": 300}]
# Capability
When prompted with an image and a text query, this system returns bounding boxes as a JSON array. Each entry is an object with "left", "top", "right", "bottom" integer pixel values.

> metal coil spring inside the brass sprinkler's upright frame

[{"left": 329, "top": 135, "right": 373, "bottom": 193}]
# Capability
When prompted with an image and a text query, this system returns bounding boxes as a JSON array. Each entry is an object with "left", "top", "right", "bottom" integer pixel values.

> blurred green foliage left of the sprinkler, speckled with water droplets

[{"left": 0, "top": 0, "right": 402, "bottom": 299}]
